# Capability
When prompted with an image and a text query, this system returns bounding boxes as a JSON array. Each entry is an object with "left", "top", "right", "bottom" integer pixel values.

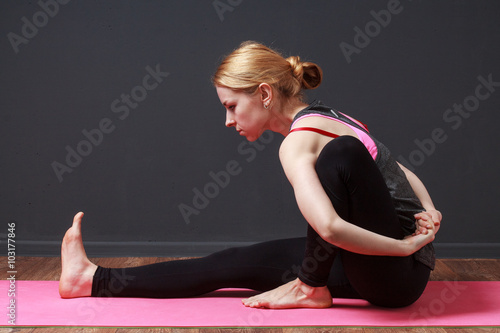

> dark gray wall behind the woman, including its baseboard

[{"left": 0, "top": 0, "right": 500, "bottom": 257}]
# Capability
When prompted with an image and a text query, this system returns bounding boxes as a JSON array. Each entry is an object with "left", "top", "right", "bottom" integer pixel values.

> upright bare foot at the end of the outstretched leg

[{"left": 59, "top": 212, "right": 97, "bottom": 298}]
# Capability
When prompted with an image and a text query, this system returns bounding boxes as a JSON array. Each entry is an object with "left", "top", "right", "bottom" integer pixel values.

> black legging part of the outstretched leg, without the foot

[{"left": 92, "top": 238, "right": 305, "bottom": 298}]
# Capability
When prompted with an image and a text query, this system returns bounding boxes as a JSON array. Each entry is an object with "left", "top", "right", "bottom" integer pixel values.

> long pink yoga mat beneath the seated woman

[{"left": 0, "top": 281, "right": 500, "bottom": 327}]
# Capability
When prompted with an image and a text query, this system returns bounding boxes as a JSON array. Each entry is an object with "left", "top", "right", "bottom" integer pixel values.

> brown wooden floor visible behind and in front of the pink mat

[{"left": 0, "top": 257, "right": 500, "bottom": 333}]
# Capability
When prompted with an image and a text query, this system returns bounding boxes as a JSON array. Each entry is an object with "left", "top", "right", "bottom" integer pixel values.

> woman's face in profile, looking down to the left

[{"left": 217, "top": 87, "right": 270, "bottom": 142}]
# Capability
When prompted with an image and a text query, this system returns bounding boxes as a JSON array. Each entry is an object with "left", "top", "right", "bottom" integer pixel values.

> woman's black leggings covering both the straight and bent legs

[{"left": 92, "top": 136, "right": 430, "bottom": 307}]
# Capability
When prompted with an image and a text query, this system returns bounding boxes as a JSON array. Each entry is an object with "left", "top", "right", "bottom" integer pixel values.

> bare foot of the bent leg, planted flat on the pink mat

[{"left": 242, "top": 279, "right": 332, "bottom": 309}]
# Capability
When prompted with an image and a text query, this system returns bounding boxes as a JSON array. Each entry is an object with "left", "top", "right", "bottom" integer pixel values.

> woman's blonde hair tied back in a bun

[{"left": 212, "top": 41, "right": 323, "bottom": 100}]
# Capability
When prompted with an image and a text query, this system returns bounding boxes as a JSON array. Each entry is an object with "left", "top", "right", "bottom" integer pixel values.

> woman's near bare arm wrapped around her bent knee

[{"left": 280, "top": 140, "right": 434, "bottom": 256}]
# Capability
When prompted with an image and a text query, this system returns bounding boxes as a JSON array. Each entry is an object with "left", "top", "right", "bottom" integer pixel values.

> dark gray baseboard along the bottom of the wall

[{"left": 6, "top": 240, "right": 500, "bottom": 259}]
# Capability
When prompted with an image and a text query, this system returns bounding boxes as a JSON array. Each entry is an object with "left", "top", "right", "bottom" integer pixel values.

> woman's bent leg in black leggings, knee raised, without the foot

[{"left": 299, "top": 136, "right": 430, "bottom": 306}]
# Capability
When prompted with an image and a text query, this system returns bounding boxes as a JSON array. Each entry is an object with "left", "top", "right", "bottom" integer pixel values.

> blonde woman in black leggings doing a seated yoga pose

[{"left": 59, "top": 42, "right": 441, "bottom": 308}]
